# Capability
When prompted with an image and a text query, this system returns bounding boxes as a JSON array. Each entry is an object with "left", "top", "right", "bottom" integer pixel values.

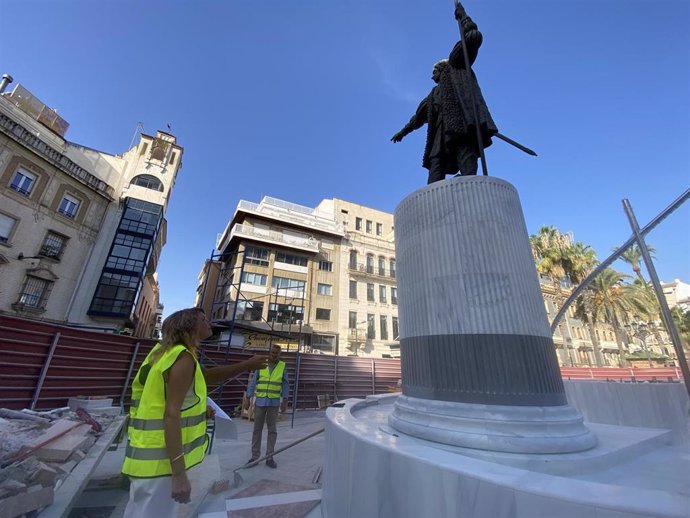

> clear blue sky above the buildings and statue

[{"left": 0, "top": 0, "right": 690, "bottom": 313}]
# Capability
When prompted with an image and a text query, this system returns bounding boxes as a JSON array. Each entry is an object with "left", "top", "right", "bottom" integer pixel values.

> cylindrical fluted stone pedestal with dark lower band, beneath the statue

[{"left": 389, "top": 176, "right": 596, "bottom": 453}]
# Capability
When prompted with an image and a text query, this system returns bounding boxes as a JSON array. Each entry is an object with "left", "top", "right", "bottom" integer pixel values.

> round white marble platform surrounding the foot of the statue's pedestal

[{"left": 321, "top": 395, "right": 690, "bottom": 518}]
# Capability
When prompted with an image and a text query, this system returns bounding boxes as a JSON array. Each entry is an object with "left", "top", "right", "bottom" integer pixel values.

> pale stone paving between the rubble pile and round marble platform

[{"left": 69, "top": 410, "right": 326, "bottom": 518}]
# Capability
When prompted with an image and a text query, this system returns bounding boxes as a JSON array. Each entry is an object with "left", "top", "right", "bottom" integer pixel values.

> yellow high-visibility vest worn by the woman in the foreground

[{"left": 122, "top": 344, "right": 208, "bottom": 478}]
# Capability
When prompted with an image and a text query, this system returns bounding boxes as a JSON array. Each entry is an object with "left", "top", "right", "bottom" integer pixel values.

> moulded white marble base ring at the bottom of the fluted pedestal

[{"left": 389, "top": 396, "right": 597, "bottom": 453}]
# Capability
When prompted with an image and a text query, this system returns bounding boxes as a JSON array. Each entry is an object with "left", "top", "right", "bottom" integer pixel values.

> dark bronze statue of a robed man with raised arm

[{"left": 391, "top": 4, "right": 498, "bottom": 183}]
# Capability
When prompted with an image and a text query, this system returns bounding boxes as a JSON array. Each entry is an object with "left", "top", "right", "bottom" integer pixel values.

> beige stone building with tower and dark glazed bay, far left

[{"left": 0, "top": 76, "right": 183, "bottom": 336}]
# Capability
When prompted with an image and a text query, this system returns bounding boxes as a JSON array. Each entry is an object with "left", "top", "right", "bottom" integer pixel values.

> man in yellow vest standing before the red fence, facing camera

[{"left": 247, "top": 344, "right": 289, "bottom": 469}]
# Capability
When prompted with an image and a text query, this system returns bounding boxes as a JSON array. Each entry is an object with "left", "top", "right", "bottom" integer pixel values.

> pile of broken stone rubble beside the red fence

[{"left": 0, "top": 404, "right": 119, "bottom": 518}]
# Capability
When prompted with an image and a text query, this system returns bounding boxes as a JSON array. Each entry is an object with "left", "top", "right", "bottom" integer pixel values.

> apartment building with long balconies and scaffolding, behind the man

[{"left": 208, "top": 197, "right": 344, "bottom": 354}]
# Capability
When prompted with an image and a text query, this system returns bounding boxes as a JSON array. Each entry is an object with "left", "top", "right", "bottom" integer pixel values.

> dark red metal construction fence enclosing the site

[{"left": 0, "top": 315, "right": 681, "bottom": 411}]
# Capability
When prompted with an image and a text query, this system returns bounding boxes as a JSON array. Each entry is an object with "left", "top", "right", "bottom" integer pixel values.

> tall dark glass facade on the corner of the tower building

[{"left": 88, "top": 198, "right": 163, "bottom": 318}]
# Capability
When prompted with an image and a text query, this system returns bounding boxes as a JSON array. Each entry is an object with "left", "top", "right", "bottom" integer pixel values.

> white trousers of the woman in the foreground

[{"left": 124, "top": 477, "right": 180, "bottom": 518}]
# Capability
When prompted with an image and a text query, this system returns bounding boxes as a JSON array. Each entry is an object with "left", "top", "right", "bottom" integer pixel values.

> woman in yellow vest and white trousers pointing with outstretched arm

[{"left": 122, "top": 308, "right": 266, "bottom": 518}]
